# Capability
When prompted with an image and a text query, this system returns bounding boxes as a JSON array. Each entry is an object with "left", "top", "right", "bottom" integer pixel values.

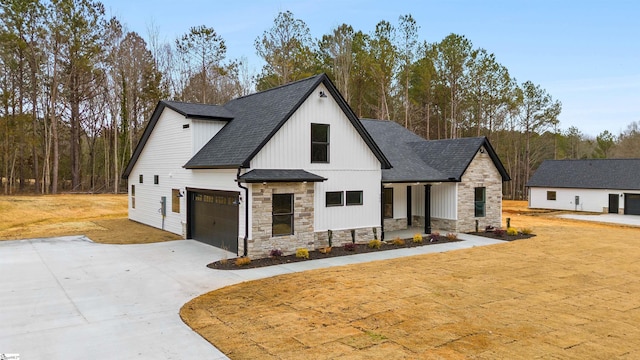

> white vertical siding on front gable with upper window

[{"left": 250, "top": 84, "right": 382, "bottom": 232}]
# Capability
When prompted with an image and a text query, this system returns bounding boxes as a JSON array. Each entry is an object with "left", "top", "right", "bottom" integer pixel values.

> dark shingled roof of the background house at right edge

[{"left": 527, "top": 159, "right": 640, "bottom": 190}]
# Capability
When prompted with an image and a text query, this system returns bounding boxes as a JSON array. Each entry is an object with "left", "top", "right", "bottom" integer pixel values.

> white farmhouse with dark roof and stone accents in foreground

[{"left": 123, "top": 74, "right": 509, "bottom": 257}]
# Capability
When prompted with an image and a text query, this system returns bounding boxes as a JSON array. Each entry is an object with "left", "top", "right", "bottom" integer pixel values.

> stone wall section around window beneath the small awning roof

[{"left": 247, "top": 182, "right": 315, "bottom": 258}]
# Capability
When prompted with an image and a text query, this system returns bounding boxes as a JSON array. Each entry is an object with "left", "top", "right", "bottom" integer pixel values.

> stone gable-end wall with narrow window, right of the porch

[{"left": 455, "top": 151, "right": 502, "bottom": 232}]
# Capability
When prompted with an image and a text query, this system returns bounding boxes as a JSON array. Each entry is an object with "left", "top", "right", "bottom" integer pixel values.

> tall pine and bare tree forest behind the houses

[{"left": 0, "top": 0, "right": 640, "bottom": 199}]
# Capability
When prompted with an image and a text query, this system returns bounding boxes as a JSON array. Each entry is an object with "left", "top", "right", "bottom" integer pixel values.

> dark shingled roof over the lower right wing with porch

[{"left": 362, "top": 119, "right": 510, "bottom": 182}]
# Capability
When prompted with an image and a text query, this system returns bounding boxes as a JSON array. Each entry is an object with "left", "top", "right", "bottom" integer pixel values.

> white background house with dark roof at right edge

[{"left": 527, "top": 159, "right": 640, "bottom": 215}]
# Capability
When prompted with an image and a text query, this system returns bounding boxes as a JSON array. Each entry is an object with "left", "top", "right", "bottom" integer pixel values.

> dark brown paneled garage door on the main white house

[{"left": 188, "top": 190, "right": 239, "bottom": 253}]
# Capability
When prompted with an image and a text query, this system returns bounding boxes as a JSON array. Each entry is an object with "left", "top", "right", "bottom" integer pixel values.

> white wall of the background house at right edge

[{"left": 529, "top": 187, "right": 625, "bottom": 212}]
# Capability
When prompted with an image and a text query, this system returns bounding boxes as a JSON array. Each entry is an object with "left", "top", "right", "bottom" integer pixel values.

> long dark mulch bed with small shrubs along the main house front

[{"left": 207, "top": 235, "right": 461, "bottom": 270}]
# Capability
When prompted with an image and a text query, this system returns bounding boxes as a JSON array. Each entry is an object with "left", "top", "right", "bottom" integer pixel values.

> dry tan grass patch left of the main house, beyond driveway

[{"left": 0, "top": 194, "right": 180, "bottom": 244}]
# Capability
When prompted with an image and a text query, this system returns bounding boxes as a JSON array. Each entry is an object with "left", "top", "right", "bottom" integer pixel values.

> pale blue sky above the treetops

[{"left": 103, "top": 0, "right": 640, "bottom": 137}]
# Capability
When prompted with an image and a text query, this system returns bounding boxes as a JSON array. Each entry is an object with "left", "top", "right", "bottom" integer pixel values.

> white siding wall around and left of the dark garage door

[{"left": 128, "top": 108, "right": 245, "bottom": 236}]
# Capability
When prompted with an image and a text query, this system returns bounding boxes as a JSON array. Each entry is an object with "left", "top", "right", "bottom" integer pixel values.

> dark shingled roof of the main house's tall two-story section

[{"left": 122, "top": 74, "right": 391, "bottom": 179}]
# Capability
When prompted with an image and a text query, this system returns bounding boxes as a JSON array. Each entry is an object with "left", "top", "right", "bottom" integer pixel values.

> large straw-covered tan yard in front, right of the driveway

[{"left": 180, "top": 201, "right": 640, "bottom": 359}]
